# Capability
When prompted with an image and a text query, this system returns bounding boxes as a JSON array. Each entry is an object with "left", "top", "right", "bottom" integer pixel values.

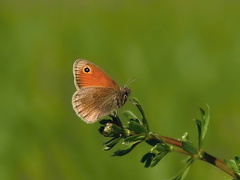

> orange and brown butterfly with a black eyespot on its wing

[{"left": 72, "top": 59, "right": 130, "bottom": 123}]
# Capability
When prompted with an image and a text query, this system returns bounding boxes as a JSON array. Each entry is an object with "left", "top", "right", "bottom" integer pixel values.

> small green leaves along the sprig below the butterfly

[{"left": 99, "top": 98, "right": 240, "bottom": 180}]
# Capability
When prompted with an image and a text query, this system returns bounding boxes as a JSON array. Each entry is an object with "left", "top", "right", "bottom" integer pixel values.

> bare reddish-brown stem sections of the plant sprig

[{"left": 154, "top": 135, "right": 240, "bottom": 179}]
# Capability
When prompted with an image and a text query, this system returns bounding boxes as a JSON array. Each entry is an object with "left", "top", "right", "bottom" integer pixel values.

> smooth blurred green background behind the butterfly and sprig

[{"left": 0, "top": 0, "right": 240, "bottom": 180}]
